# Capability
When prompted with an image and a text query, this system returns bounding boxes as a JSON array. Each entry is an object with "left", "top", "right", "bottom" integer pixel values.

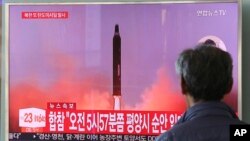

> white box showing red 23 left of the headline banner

[{"left": 19, "top": 108, "right": 46, "bottom": 128}]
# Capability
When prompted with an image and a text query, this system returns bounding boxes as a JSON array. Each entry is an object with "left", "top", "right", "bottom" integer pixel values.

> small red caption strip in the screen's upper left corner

[{"left": 21, "top": 11, "right": 69, "bottom": 19}]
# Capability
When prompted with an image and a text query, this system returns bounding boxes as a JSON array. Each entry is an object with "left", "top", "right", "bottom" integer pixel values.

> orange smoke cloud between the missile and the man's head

[{"left": 127, "top": 67, "right": 186, "bottom": 112}]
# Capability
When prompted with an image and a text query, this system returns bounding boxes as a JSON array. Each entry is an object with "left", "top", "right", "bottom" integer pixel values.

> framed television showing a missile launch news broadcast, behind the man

[{"left": 1, "top": 0, "right": 241, "bottom": 141}]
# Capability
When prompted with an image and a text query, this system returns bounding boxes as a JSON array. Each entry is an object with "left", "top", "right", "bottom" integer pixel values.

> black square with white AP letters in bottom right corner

[{"left": 230, "top": 125, "right": 250, "bottom": 141}]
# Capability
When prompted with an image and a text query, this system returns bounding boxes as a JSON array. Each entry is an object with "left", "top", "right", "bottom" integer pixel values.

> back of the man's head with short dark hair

[{"left": 176, "top": 43, "right": 233, "bottom": 102}]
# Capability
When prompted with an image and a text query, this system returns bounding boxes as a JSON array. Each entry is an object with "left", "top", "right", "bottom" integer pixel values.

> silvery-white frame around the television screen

[{"left": 0, "top": 0, "right": 242, "bottom": 141}]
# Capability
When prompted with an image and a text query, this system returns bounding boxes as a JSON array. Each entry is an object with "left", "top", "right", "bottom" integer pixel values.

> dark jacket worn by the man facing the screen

[{"left": 156, "top": 102, "right": 244, "bottom": 141}]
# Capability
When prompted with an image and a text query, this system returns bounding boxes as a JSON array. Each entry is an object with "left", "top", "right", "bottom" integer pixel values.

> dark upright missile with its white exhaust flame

[{"left": 113, "top": 24, "right": 121, "bottom": 110}]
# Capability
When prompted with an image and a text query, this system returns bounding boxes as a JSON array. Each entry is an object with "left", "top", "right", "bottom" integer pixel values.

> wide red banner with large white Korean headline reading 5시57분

[{"left": 44, "top": 109, "right": 181, "bottom": 135}]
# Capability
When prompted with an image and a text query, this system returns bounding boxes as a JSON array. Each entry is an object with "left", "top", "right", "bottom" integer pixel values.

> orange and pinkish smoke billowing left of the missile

[{"left": 9, "top": 51, "right": 113, "bottom": 132}]
